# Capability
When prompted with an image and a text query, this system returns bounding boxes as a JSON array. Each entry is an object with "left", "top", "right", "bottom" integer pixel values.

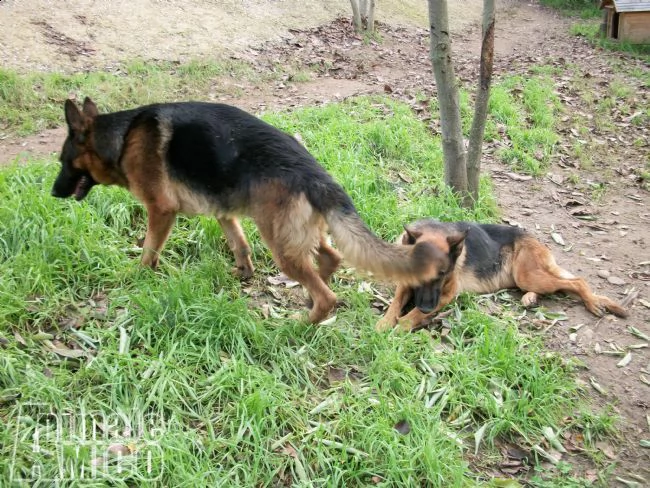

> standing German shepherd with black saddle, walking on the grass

[{"left": 52, "top": 98, "right": 438, "bottom": 323}]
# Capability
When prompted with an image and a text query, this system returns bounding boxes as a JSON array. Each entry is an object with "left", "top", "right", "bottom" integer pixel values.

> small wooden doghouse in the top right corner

[{"left": 600, "top": 0, "right": 650, "bottom": 44}]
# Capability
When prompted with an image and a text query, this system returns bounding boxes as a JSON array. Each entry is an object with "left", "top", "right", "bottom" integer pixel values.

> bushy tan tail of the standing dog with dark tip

[{"left": 325, "top": 208, "right": 436, "bottom": 286}]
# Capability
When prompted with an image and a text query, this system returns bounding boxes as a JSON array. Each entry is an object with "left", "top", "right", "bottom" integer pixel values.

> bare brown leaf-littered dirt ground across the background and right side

[{"left": 0, "top": 0, "right": 650, "bottom": 486}]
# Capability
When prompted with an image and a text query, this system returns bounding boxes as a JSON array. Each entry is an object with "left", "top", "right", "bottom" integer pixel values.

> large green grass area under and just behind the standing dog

[{"left": 0, "top": 98, "right": 602, "bottom": 488}]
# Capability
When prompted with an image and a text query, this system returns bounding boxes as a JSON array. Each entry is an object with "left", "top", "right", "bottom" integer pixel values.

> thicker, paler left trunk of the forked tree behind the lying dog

[{"left": 429, "top": 0, "right": 472, "bottom": 207}]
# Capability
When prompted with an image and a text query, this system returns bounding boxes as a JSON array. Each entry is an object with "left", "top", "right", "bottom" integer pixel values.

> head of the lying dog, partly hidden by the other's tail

[{"left": 402, "top": 220, "right": 469, "bottom": 313}]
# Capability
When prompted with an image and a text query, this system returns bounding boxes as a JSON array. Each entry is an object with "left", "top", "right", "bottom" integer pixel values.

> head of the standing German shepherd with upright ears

[{"left": 52, "top": 98, "right": 124, "bottom": 200}]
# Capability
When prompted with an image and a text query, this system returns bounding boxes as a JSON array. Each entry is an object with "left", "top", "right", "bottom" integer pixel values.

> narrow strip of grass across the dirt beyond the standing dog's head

[{"left": 0, "top": 59, "right": 310, "bottom": 135}]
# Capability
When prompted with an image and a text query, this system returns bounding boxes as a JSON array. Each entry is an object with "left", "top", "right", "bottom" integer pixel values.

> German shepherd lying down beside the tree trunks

[{"left": 376, "top": 220, "right": 627, "bottom": 331}]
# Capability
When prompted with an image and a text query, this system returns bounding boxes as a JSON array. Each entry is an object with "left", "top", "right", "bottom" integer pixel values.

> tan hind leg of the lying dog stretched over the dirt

[{"left": 513, "top": 239, "right": 627, "bottom": 317}]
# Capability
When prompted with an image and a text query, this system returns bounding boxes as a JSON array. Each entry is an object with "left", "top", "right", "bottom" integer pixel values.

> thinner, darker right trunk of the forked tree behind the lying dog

[{"left": 467, "top": 0, "right": 495, "bottom": 202}]
